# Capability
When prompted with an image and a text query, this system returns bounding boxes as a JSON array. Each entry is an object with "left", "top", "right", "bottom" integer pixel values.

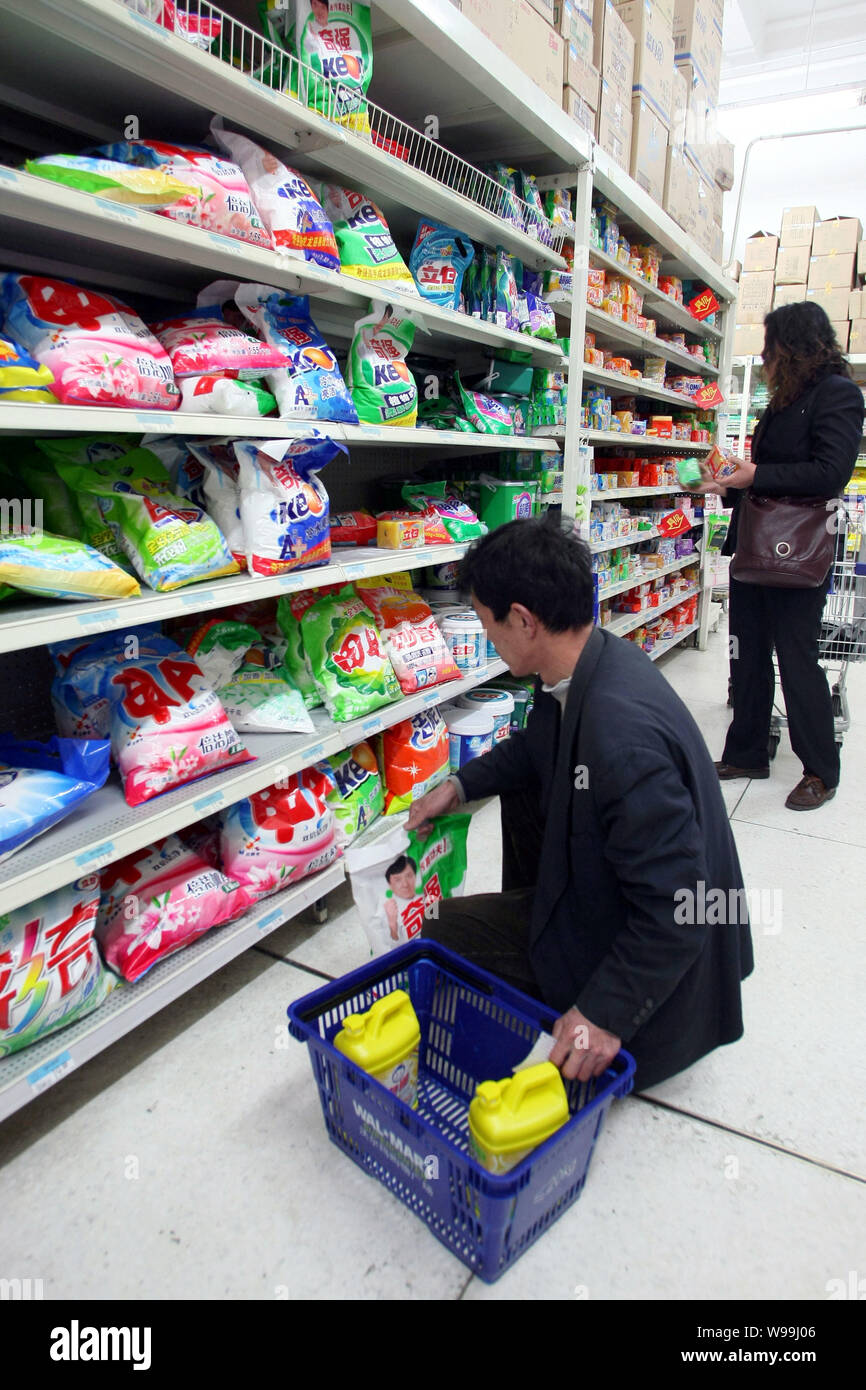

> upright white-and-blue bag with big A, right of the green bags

[{"left": 235, "top": 438, "right": 346, "bottom": 575}]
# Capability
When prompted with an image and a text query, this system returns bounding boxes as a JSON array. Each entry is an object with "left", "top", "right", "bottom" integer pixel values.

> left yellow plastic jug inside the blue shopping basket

[{"left": 334, "top": 990, "right": 421, "bottom": 1109}]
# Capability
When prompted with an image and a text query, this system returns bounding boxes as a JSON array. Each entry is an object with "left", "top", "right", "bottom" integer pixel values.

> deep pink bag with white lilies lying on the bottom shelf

[{"left": 96, "top": 835, "right": 253, "bottom": 980}]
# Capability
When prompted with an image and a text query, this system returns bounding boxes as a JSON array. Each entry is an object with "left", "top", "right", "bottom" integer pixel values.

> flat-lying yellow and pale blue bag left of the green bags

[{"left": 0, "top": 531, "right": 142, "bottom": 599}]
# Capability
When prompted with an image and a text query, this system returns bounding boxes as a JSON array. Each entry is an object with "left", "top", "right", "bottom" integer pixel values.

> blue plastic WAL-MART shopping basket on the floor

[{"left": 288, "top": 941, "right": 635, "bottom": 1283}]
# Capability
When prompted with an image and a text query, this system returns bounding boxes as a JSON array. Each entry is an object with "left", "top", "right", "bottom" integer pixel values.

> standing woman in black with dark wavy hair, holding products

[{"left": 706, "top": 302, "right": 863, "bottom": 810}]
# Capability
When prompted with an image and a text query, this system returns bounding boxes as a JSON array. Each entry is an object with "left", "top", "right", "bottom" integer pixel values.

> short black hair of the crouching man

[{"left": 457, "top": 513, "right": 594, "bottom": 632}]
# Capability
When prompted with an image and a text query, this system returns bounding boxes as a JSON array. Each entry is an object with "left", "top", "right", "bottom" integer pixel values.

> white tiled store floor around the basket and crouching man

[{"left": 0, "top": 634, "right": 866, "bottom": 1300}]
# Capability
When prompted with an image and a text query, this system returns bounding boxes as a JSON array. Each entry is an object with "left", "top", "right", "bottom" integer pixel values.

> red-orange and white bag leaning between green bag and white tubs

[{"left": 354, "top": 580, "right": 460, "bottom": 695}]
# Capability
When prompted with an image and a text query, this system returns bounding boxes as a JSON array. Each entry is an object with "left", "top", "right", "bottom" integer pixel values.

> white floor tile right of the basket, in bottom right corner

[{"left": 463, "top": 1099, "right": 866, "bottom": 1304}]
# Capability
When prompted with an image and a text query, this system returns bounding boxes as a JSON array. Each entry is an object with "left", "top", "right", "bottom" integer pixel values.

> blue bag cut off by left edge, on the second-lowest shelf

[{"left": 0, "top": 734, "right": 110, "bottom": 862}]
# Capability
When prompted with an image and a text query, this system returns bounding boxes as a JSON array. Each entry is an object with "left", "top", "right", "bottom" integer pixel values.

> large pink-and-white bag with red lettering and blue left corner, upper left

[{"left": 1, "top": 272, "right": 181, "bottom": 410}]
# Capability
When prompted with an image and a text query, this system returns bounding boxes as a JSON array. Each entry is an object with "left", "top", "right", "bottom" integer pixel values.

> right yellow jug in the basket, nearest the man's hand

[{"left": 468, "top": 1062, "right": 569, "bottom": 1173}]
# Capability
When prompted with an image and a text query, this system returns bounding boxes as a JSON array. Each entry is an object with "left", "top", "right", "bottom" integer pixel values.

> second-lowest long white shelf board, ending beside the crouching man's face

[{"left": 0, "top": 662, "right": 507, "bottom": 912}]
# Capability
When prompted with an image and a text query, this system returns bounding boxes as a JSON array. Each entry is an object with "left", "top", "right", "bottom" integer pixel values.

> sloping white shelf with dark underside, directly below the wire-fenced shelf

[{"left": 0, "top": 164, "right": 562, "bottom": 370}]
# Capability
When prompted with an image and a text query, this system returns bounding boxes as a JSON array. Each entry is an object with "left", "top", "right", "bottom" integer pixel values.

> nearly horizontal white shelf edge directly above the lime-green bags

[{"left": 0, "top": 400, "right": 552, "bottom": 450}]
